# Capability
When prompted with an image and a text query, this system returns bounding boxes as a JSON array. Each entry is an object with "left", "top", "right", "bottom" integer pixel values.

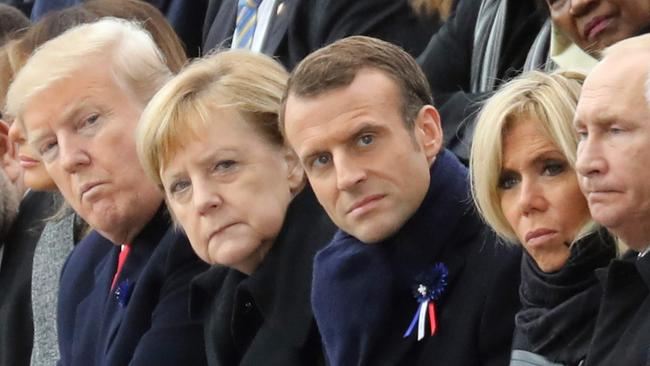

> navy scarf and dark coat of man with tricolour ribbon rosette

[{"left": 312, "top": 151, "right": 521, "bottom": 366}]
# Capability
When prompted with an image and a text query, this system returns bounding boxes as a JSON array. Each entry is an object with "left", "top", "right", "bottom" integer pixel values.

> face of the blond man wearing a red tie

[{"left": 22, "top": 65, "right": 162, "bottom": 244}]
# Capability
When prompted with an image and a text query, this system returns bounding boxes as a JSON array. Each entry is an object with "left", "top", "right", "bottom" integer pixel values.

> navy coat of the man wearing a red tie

[{"left": 57, "top": 209, "right": 207, "bottom": 366}]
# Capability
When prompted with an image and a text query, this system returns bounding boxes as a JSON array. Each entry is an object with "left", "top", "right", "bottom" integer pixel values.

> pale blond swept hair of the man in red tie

[{"left": 6, "top": 18, "right": 172, "bottom": 120}]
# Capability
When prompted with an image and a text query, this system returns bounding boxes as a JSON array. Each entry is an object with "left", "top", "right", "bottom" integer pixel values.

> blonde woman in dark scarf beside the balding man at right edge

[{"left": 470, "top": 71, "right": 616, "bottom": 365}]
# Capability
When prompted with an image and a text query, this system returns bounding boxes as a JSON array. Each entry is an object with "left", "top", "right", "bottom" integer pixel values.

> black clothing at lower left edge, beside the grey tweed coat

[{"left": 0, "top": 191, "right": 57, "bottom": 366}]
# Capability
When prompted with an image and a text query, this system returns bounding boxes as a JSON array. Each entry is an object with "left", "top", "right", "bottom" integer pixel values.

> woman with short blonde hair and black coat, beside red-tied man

[{"left": 136, "top": 50, "right": 334, "bottom": 365}]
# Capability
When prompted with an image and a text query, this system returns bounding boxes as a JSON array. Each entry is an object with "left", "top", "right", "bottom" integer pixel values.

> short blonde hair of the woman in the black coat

[{"left": 136, "top": 50, "right": 289, "bottom": 190}]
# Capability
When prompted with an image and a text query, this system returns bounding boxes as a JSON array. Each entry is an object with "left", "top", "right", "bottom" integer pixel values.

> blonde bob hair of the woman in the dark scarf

[{"left": 470, "top": 71, "right": 596, "bottom": 243}]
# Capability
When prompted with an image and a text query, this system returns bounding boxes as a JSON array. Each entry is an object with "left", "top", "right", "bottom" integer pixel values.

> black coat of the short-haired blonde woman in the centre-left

[{"left": 192, "top": 187, "right": 335, "bottom": 366}]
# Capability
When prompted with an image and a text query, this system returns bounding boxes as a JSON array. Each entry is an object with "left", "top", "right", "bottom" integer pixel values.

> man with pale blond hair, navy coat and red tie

[{"left": 7, "top": 19, "right": 206, "bottom": 365}]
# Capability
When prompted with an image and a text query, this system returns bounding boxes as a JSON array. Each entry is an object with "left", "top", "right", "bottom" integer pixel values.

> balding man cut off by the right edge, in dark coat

[{"left": 574, "top": 35, "right": 650, "bottom": 366}]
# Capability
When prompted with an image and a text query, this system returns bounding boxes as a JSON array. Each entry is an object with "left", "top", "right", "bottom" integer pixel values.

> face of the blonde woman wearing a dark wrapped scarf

[{"left": 498, "top": 118, "right": 590, "bottom": 272}]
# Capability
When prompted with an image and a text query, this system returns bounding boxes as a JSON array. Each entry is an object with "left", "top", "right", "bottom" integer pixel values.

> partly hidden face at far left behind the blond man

[{"left": 9, "top": 123, "right": 56, "bottom": 191}]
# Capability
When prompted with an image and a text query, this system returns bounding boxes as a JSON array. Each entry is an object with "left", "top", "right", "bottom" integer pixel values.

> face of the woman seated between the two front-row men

[{"left": 161, "top": 109, "right": 303, "bottom": 273}]
